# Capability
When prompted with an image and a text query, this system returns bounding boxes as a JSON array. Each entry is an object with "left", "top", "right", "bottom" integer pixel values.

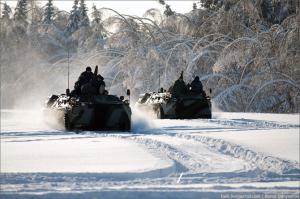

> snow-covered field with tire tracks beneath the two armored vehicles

[{"left": 0, "top": 110, "right": 300, "bottom": 198}]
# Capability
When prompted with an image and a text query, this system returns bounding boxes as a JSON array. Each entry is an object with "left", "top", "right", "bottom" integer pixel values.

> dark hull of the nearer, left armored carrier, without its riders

[{"left": 44, "top": 90, "right": 131, "bottom": 131}]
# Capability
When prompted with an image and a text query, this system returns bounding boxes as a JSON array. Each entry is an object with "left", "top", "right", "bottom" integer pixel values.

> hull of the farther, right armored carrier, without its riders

[{"left": 136, "top": 92, "right": 211, "bottom": 119}]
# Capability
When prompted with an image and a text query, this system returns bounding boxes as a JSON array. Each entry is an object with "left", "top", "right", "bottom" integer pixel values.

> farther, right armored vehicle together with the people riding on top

[{"left": 137, "top": 72, "right": 211, "bottom": 119}]
